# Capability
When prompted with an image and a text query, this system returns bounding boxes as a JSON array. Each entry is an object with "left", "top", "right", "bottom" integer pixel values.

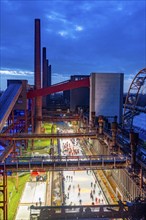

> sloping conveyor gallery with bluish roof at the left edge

[{"left": 0, "top": 83, "right": 22, "bottom": 131}]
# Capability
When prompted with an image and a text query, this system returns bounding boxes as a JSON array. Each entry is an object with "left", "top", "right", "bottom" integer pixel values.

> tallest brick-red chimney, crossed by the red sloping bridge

[{"left": 34, "top": 19, "right": 42, "bottom": 133}]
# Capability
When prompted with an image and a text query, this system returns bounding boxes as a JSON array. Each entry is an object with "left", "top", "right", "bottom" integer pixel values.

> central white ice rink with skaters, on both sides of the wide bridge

[{"left": 60, "top": 138, "right": 107, "bottom": 205}]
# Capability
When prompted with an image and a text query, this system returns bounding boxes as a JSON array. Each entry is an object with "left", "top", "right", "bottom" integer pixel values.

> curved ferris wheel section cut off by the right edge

[{"left": 123, "top": 68, "right": 146, "bottom": 129}]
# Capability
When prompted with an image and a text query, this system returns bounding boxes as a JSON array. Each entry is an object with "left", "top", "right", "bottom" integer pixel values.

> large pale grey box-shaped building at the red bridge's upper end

[{"left": 90, "top": 73, "right": 124, "bottom": 123}]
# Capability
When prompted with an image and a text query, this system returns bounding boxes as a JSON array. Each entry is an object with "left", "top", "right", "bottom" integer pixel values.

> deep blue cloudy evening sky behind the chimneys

[{"left": 0, "top": 0, "right": 146, "bottom": 91}]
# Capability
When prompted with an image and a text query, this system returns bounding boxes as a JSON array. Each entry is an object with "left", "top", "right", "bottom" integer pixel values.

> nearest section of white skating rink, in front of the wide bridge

[{"left": 63, "top": 171, "right": 106, "bottom": 205}]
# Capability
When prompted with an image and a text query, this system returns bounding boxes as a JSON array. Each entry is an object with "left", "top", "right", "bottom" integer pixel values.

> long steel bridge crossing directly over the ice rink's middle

[{"left": 0, "top": 155, "right": 128, "bottom": 172}]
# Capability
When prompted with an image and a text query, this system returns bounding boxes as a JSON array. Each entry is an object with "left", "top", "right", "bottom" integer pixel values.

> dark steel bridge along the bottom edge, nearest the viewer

[{"left": 30, "top": 202, "right": 146, "bottom": 220}]
